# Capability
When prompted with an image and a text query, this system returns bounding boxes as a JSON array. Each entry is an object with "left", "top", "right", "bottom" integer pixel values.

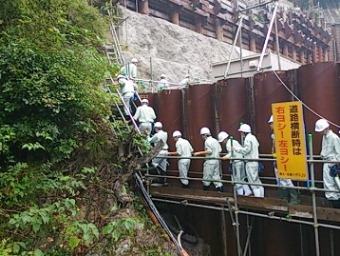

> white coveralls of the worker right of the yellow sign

[{"left": 320, "top": 130, "right": 340, "bottom": 200}]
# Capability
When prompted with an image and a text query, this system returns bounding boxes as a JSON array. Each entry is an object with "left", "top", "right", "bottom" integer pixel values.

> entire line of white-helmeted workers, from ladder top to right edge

[{"left": 117, "top": 59, "right": 340, "bottom": 208}]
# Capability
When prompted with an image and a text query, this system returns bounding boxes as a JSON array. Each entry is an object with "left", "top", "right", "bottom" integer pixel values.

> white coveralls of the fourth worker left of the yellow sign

[{"left": 176, "top": 138, "right": 194, "bottom": 185}]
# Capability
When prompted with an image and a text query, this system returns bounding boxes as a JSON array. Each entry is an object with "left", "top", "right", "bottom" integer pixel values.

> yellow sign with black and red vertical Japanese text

[{"left": 272, "top": 101, "right": 308, "bottom": 180}]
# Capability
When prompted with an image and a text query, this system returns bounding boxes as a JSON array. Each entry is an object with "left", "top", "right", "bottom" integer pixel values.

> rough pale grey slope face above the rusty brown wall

[{"left": 119, "top": 8, "right": 249, "bottom": 83}]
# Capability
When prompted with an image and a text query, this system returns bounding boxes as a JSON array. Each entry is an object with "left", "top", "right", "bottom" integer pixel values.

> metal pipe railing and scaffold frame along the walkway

[{"left": 144, "top": 134, "right": 340, "bottom": 256}]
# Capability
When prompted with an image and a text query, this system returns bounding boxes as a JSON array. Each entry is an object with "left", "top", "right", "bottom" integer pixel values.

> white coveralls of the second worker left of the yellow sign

[{"left": 226, "top": 139, "right": 252, "bottom": 196}]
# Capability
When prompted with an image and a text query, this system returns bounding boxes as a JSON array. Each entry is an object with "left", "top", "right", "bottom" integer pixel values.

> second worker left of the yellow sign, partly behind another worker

[{"left": 217, "top": 131, "right": 252, "bottom": 196}]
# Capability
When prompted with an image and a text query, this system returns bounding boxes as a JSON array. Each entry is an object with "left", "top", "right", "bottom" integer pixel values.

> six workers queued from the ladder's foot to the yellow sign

[{"left": 133, "top": 99, "right": 270, "bottom": 197}]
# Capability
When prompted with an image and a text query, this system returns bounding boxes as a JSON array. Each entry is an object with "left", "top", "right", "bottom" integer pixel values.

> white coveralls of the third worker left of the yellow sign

[{"left": 203, "top": 136, "right": 223, "bottom": 188}]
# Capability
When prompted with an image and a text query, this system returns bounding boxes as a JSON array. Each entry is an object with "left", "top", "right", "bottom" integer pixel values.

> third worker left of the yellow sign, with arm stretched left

[{"left": 194, "top": 127, "right": 223, "bottom": 192}]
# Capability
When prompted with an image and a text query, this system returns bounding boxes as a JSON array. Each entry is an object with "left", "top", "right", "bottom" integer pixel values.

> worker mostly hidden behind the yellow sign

[{"left": 268, "top": 115, "right": 300, "bottom": 205}]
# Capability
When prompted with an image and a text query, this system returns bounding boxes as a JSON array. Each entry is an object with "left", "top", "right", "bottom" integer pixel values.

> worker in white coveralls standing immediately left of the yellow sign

[{"left": 232, "top": 124, "right": 264, "bottom": 197}]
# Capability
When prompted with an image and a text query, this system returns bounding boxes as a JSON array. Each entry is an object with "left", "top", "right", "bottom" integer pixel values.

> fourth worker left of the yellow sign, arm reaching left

[{"left": 169, "top": 131, "right": 194, "bottom": 188}]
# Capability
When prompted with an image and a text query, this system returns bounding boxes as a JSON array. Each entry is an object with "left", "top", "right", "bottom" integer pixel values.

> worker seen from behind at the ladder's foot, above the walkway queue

[{"left": 133, "top": 99, "right": 156, "bottom": 135}]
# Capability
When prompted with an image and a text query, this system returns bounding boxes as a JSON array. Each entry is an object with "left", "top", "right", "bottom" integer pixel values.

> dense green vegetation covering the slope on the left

[{"left": 0, "top": 0, "right": 175, "bottom": 256}]
